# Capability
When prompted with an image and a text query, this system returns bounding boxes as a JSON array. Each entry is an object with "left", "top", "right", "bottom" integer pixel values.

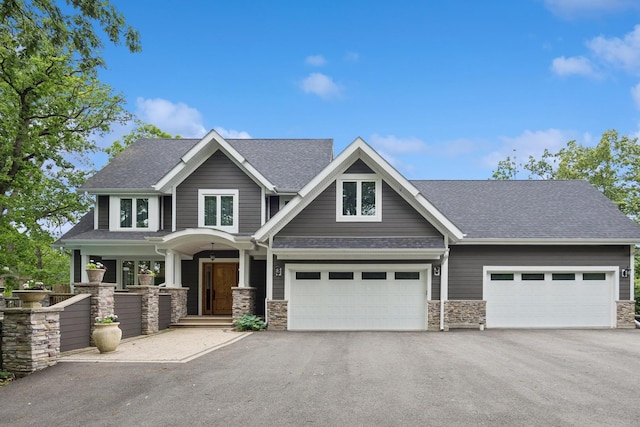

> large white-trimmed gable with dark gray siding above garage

[{"left": 255, "top": 138, "right": 463, "bottom": 241}]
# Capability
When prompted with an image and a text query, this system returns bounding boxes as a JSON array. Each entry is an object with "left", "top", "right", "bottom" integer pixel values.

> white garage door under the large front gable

[{"left": 287, "top": 266, "right": 430, "bottom": 330}]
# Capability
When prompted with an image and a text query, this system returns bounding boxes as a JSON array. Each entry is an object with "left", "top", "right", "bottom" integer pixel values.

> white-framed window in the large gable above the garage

[{"left": 336, "top": 174, "right": 382, "bottom": 221}]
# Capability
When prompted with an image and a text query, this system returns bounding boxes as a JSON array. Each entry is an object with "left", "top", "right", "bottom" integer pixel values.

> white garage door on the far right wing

[{"left": 484, "top": 271, "right": 615, "bottom": 328}]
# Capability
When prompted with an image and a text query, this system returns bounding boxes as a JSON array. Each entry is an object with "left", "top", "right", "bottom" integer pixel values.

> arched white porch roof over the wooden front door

[{"left": 147, "top": 228, "right": 255, "bottom": 255}]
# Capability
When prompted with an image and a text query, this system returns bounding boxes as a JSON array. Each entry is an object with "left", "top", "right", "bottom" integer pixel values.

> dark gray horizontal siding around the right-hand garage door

[{"left": 449, "top": 246, "right": 629, "bottom": 300}]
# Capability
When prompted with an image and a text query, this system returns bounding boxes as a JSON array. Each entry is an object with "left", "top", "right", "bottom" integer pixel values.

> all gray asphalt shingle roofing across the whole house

[{"left": 70, "top": 139, "right": 640, "bottom": 244}]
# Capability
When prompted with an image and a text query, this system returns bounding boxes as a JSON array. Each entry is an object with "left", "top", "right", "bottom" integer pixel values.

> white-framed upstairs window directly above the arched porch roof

[{"left": 198, "top": 190, "right": 238, "bottom": 233}]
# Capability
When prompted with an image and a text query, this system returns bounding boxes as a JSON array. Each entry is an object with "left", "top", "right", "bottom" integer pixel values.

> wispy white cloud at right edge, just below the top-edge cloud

[{"left": 587, "top": 25, "right": 640, "bottom": 73}]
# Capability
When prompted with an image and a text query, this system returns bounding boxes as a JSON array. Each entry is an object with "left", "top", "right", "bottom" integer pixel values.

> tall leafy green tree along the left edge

[{"left": 0, "top": 0, "right": 140, "bottom": 282}]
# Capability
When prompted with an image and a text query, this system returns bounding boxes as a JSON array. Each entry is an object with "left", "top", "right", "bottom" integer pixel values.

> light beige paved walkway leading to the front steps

[{"left": 59, "top": 328, "right": 251, "bottom": 363}]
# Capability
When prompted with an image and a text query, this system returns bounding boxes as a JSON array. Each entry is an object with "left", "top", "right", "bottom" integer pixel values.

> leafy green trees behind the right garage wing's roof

[{"left": 492, "top": 130, "right": 640, "bottom": 221}]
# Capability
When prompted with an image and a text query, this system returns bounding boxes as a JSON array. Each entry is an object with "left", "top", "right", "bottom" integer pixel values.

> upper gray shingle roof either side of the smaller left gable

[{"left": 82, "top": 138, "right": 333, "bottom": 192}]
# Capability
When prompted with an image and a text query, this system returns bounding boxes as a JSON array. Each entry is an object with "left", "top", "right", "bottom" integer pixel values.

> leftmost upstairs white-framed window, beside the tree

[{"left": 109, "top": 196, "right": 159, "bottom": 231}]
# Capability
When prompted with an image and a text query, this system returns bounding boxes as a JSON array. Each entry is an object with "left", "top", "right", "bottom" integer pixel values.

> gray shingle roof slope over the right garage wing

[{"left": 411, "top": 180, "right": 640, "bottom": 241}]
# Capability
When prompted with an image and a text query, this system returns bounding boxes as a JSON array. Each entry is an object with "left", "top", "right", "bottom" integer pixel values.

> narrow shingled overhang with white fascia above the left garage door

[{"left": 272, "top": 237, "right": 446, "bottom": 260}]
